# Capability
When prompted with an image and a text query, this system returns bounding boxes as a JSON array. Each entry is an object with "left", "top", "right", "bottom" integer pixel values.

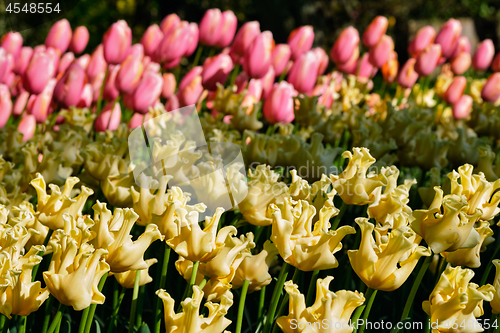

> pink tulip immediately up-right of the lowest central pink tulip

[{"left": 287, "top": 51, "right": 319, "bottom": 93}]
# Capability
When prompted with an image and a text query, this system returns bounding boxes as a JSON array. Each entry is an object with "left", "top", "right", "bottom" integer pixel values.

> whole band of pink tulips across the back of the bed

[{"left": 0, "top": 9, "right": 500, "bottom": 138}]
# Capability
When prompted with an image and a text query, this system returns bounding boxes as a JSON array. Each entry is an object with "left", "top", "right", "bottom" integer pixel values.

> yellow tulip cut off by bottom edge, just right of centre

[{"left": 276, "top": 276, "right": 365, "bottom": 333}]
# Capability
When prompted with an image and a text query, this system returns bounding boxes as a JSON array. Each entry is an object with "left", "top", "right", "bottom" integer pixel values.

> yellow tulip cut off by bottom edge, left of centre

[{"left": 156, "top": 286, "right": 233, "bottom": 333}]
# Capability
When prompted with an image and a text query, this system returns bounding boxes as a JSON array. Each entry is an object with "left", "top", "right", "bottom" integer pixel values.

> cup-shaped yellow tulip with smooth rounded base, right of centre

[{"left": 347, "top": 217, "right": 431, "bottom": 291}]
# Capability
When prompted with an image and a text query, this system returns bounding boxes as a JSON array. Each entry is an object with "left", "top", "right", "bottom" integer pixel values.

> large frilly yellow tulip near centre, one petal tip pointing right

[{"left": 269, "top": 198, "right": 356, "bottom": 271}]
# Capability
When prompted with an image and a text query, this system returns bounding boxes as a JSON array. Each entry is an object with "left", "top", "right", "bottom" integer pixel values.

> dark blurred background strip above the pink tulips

[{"left": 0, "top": 0, "right": 500, "bottom": 60}]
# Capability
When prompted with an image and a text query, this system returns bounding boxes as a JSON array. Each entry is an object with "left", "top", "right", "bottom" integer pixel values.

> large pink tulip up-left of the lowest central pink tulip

[{"left": 243, "top": 31, "right": 274, "bottom": 78}]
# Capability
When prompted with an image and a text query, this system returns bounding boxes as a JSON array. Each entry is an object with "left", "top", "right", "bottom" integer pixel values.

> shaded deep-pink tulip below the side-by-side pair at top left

[{"left": 54, "top": 63, "right": 87, "bottom": 107}]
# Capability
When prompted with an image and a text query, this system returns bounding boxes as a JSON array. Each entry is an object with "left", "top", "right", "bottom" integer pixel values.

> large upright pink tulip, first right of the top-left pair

[{"left": 102, "top": 20, "right": 132, "bottom": 65}]
